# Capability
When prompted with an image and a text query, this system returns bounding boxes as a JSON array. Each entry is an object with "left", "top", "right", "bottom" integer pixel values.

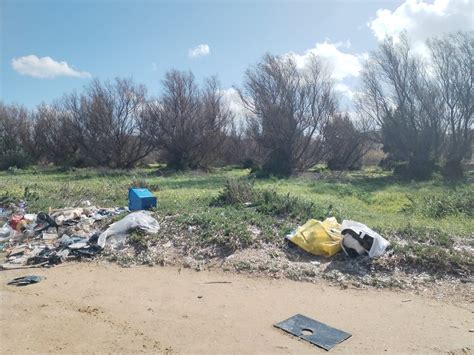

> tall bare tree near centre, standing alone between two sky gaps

[{"left": 239, "top": 54, "right": 337, "bottom": 176}]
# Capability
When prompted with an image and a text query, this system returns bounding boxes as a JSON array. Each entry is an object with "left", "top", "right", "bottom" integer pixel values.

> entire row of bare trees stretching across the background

[{"left": 0, "top": 33, "right": 474, "bottom": 178}]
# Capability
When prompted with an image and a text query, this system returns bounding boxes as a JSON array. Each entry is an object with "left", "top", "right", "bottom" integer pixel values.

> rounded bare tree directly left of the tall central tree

[{"left": 144, "top": 70, "right": 232, "bottom": 170}]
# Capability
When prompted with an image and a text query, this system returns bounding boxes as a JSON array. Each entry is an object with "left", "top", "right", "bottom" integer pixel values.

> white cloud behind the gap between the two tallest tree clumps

[{"left": 289, "top": 40, "right": 367, "bottom": 81}]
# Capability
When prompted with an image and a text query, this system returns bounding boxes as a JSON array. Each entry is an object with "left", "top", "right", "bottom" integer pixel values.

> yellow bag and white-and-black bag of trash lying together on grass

[{"left": 286, "top": 217, "right": 390, "bottom": 258}]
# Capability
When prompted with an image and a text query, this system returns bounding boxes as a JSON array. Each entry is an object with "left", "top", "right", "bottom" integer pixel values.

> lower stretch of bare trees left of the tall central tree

[{"left": 0, "top": 71, "right": 232, "bottom": 169}]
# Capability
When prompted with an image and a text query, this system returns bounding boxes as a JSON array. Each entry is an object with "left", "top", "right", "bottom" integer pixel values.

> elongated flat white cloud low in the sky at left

[{"left": 11, "top": 54, "right": 91, "bottom": 79}]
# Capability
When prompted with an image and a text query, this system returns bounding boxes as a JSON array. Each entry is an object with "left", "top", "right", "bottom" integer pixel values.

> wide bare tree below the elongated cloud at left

[{"left": 66, "top": 78, "right": 153, "bottom": 169}]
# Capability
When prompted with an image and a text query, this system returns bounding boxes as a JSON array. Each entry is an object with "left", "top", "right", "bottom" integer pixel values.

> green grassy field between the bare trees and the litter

[{"left": 0, "top": 168, "right": 474, "bottom": 276}]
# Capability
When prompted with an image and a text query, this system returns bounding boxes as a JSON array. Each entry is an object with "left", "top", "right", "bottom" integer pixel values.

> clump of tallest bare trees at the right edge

[{"left": 358, "top": 33, "right": 474, "bottom": 179}]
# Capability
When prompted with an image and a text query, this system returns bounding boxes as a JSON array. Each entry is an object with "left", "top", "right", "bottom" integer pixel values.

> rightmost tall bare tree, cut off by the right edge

[{"left": 428, "top": 32, "right": 474, "bottom": 178}]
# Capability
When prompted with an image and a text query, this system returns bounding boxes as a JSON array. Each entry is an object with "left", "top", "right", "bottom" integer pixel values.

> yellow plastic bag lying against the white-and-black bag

[{"left": 289, "top": 217, "right": 342, "bottom": 257}]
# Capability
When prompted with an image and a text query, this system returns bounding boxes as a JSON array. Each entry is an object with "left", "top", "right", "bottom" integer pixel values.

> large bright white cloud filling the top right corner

[{"left": 367, "top": 0, "right": 474, "bottom": 45}]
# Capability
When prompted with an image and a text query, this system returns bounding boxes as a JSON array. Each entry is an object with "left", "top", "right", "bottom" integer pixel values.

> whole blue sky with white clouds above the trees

[{"left": 0, "top": 0, "right": 474, "bottom": 111}]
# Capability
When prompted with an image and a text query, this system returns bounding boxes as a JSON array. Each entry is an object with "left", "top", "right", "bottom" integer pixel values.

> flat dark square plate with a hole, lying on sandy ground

[{"left": 275, "top": 314, "right": 352, "bottom": 350}]
